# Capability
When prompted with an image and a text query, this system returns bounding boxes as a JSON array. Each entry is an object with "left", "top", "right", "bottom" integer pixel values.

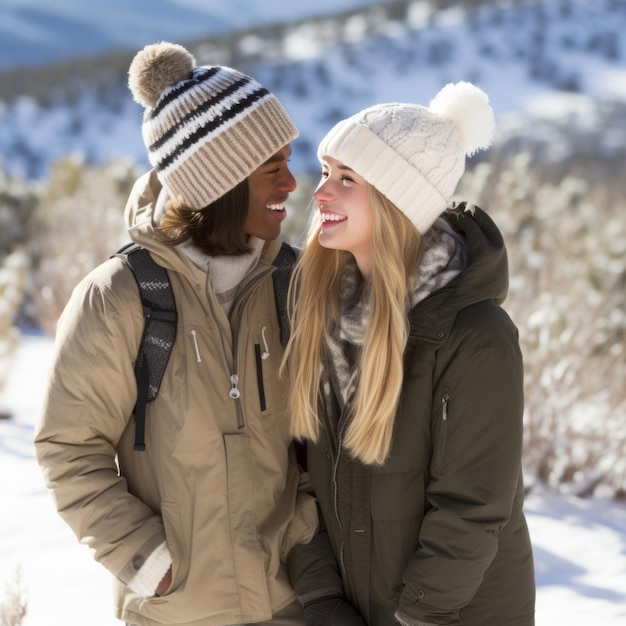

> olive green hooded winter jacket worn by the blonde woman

[{"left": 289, "top": 205, "right": 535, "bottom": 626}]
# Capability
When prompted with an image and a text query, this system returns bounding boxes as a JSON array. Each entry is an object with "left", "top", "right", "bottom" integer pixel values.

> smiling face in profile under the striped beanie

[{"left": 243, "top": 144, "right": 296, "bottom": 241}]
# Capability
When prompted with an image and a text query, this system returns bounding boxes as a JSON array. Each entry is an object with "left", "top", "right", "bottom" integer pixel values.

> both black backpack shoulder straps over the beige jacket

[{"left": 114, "top": 243, "right": 299, "bottom": 450}]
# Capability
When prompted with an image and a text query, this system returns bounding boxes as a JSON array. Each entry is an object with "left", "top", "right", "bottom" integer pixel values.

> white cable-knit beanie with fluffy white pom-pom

[{"left": 317, "top": 82, "right": 495, "bottom": 234}]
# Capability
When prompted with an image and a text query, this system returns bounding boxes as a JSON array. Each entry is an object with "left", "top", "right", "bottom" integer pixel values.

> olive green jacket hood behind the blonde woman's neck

[{"left": 409, "top": 202, "right": 509, "bottom": 342}]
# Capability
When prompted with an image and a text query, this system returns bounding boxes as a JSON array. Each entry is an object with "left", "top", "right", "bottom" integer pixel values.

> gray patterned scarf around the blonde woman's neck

[{"left": 322, "top": 218, "right": 467, "bottom": 410}]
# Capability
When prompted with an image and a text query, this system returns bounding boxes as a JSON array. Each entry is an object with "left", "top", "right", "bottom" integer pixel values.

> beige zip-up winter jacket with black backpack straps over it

[{"left": 35, "top": 173, "right": 317, "bottom": 626}]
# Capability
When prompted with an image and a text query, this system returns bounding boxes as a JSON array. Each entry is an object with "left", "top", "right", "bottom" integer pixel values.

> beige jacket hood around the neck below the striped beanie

[{"left": 124, "top": 170, "right": 281, "bottom": 273}]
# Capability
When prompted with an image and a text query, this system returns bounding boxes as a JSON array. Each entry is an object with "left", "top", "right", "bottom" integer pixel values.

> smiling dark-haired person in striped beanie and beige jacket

[{"left": 35, "top": 43, "right": 317, "bottom": 626}]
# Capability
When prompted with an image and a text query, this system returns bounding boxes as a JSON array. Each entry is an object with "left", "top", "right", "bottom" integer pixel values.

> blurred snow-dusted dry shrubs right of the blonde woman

[{"left": 460, "top": 146, "right": 626, "bottom": 497}]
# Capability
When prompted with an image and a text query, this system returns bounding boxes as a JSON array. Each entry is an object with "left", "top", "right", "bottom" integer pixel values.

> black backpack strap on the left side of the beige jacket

[{"left": 114, "top": 243, "right": 178, "bottom": 450}]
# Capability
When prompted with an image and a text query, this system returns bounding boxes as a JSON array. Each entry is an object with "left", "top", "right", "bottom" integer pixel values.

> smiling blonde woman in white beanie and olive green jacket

[{"left": 286, "top": 83, "right": 534, "bottom": 626}]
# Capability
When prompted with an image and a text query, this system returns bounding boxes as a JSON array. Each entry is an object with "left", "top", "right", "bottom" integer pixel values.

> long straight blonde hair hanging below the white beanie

[{"left": 283, "top": 185, "right": 421, "bottom": 464}]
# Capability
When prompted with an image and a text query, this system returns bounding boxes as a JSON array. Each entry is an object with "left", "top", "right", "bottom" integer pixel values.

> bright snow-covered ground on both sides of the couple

[{"left": 0, "top": 335, "right": 626, "bottom": 626}]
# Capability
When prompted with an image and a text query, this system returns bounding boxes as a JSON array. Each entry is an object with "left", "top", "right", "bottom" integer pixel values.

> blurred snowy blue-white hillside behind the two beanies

[{"left": 0, "top": 0, "right": 626, "bottom": 178}]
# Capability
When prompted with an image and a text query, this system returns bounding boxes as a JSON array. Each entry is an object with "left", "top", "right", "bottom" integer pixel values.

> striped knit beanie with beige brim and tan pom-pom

[{"left": 128, "top": 42, "right": 298, "bottom": 210}]
